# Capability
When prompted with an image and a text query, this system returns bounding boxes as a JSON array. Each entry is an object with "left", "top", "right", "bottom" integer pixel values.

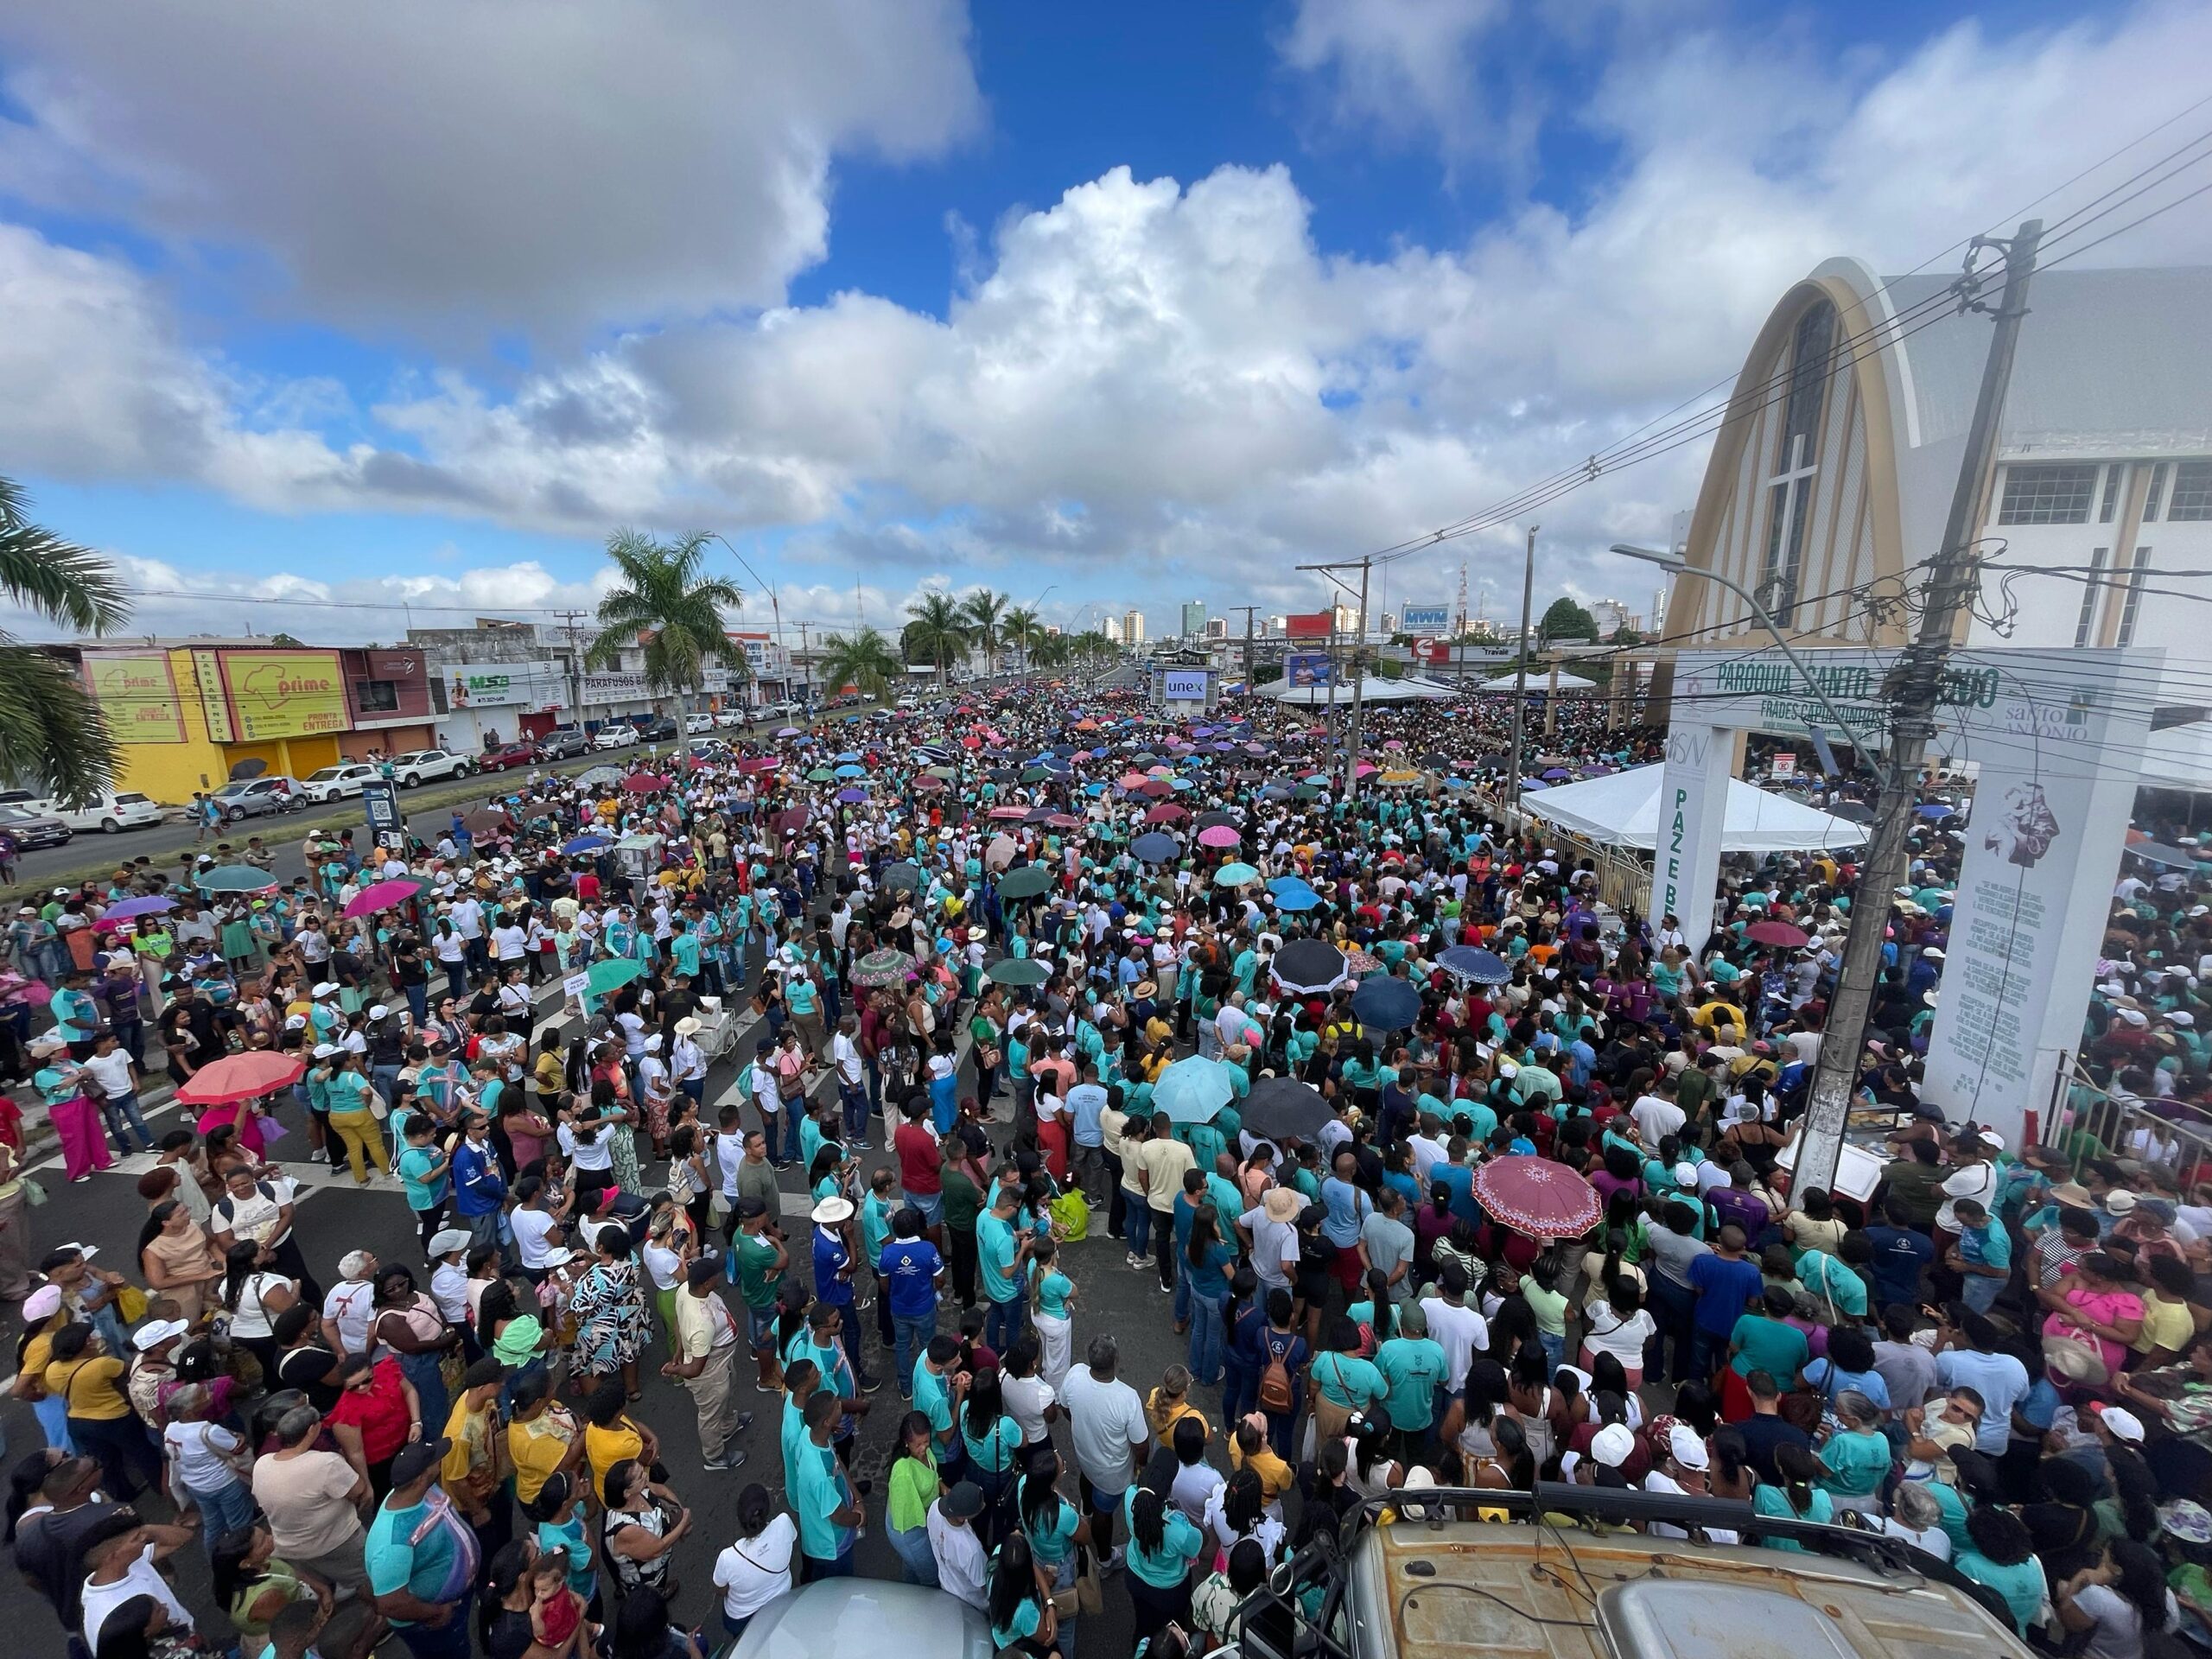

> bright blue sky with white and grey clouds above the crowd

[{"left": 0, "top": 0, "right": 2212, "bottom": 639}]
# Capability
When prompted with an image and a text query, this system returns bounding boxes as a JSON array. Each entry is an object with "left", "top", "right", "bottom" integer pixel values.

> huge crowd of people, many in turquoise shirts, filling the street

[{"left": 0, "top": 688, "right": 2212, "bottom": 1659}]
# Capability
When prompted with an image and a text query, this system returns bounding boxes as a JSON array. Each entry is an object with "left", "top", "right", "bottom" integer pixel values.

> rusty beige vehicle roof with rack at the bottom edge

[{"left": 1356, "top": 1522, "right": 2029, "bottom": 1659}]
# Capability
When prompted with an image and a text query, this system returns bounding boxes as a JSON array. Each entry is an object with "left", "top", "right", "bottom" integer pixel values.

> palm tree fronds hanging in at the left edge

[{"left": 0, "top": 478, "right": 130, "bottom": 801}]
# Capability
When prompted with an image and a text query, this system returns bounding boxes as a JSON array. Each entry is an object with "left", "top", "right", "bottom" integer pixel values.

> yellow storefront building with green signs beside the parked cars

[{"left": 84, "top": 644, "right": 349, "bottom": 805}]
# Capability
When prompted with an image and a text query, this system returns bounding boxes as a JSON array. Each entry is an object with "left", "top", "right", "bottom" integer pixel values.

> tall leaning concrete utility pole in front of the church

[{"left": 1792, "top": 219, "right": 2044, "bottom": 1194}]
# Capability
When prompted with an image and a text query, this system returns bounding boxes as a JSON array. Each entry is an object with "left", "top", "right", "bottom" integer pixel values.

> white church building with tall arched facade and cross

[{"left": 1666, "top": 259, "right": 2212, "bottom": 790}]
